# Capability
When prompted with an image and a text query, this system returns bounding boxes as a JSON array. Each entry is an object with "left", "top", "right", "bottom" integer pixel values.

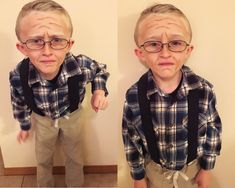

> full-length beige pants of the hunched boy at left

[{"left": 33, "top": 110, "right": 84, "bottom": 187}]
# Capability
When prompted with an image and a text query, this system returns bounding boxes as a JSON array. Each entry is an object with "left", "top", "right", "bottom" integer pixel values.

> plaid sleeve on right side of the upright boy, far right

[{"left": 200, "top": 89, "right": 222, "bottom": 170}]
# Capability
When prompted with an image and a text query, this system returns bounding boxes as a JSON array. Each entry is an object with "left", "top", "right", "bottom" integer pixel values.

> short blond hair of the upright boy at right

[{"left": 134, "top": 4, "right": 192, "bottom": 46}]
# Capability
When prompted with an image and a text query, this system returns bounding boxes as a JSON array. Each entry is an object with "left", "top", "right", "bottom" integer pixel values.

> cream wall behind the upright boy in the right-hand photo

[{"left": 118, "top": 0, "right": 235, "bottom": 188}]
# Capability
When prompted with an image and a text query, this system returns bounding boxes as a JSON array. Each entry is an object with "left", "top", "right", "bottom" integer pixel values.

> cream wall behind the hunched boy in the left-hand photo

[{"left": 0, "top": 0, "right": 118, "bottom": 167}]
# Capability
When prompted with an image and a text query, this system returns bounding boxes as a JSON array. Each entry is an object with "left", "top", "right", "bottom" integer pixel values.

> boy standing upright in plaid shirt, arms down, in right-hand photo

[{"left": 122, "top": 4, "right": 221, "bottom": 188}]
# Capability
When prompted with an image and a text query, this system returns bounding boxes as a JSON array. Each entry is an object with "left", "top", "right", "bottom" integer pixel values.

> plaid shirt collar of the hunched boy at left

[{"left": 29, "top": 53, "right": 82, "bottom": 85}]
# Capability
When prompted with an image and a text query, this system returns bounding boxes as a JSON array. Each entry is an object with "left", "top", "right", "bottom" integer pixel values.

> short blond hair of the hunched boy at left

[{"left": 15, "top": 0, "right": 73, "bottom": 40}]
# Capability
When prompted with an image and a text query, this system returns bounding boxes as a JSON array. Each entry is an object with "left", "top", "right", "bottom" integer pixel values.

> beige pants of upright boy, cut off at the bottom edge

[{"left": 146, "top": 160, "right": 199, "bottom": 188}]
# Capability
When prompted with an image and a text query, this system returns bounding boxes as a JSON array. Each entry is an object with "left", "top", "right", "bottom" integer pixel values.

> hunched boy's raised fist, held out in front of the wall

[{"left": 91, "top": 90, "right": 108, "bottom": 112}]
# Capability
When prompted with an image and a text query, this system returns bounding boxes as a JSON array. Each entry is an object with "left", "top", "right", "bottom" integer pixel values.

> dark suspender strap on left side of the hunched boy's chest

[{"left": 19, "top": 58, "right": 44, "bottom": 116}]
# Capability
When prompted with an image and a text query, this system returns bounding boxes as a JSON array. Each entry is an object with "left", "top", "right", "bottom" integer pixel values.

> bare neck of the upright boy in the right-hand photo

[{"left": 154, "top": 71, "right": 182, "bottom": 93}]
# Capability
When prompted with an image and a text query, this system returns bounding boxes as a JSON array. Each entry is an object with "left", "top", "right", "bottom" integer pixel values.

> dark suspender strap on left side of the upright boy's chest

[{"left": 138, "top": 73, "right": 160, "bottom": 164}]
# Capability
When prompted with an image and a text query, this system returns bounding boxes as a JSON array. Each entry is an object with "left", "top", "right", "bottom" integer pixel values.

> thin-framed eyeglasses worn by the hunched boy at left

[{"left": 22, "top": 38, "right": 70, "bottom": 50}]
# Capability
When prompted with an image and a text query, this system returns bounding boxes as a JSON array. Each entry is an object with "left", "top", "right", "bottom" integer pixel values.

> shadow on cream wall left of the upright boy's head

[{"left": 118, "top": 15, "right": 147, "bottom": 107}]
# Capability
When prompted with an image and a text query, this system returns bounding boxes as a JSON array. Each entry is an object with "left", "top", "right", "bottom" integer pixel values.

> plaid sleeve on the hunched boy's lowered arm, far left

[{"left": 10, "top": 72, "right": 31, "bottom": 130}]
